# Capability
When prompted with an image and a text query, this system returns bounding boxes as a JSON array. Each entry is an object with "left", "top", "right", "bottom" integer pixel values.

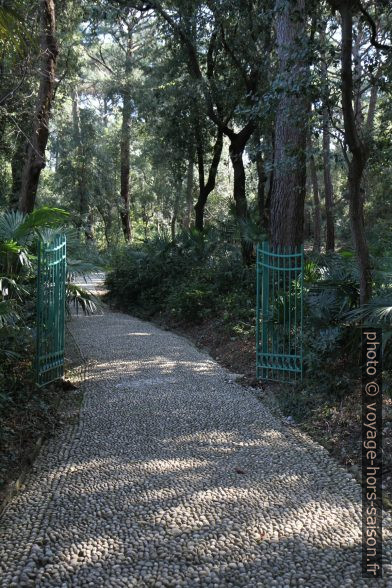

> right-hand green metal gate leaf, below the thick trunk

[{"left": 256, "top": 241, "right": 304, "bottom": 383}]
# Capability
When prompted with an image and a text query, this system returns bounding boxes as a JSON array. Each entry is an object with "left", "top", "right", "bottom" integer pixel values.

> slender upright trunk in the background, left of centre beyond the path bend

[{"left": 120, "top": 30, "right": 132, "bottom": 243}]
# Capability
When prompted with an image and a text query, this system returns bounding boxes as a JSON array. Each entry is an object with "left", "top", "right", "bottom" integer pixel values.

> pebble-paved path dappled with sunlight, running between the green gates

[{"left": 0, "top": 278, "right": 392, "bottom": 588}]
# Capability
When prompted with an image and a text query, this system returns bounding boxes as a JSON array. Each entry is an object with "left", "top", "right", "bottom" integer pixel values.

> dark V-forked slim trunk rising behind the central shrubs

[{"left": 195, "top": 125, "right": 223, "bottom": 232}]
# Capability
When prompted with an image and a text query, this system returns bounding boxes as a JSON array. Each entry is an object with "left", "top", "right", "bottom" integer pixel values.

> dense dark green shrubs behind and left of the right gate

[{"left": 107, "top": 231, "right": 255, "bottom": 328}]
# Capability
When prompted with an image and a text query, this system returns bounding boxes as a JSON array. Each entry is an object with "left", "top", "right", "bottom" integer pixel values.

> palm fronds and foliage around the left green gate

[{"left": 0, "top": 207, "right": 102, "bottom": 485}]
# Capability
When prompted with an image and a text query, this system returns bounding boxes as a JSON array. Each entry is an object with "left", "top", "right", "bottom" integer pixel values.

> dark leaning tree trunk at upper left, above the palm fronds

[{"left": 19, "top": 0, "right": 58, "bottom": 213}]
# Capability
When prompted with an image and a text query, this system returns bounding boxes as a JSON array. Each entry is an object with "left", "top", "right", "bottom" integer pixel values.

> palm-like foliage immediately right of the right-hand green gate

[{"left": 304, "top": 251, "right": 392, "bottom": 396}]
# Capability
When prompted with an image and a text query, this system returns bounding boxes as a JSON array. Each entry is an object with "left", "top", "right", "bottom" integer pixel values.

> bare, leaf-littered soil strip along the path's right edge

[{"left": 152, "top": 316, "right": 392, "bottom": 509}]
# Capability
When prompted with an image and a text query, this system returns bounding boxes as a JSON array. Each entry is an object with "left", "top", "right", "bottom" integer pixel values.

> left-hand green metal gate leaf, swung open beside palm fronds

[{"left": 36, "top": 235, "right": 66, "bottom": 386}]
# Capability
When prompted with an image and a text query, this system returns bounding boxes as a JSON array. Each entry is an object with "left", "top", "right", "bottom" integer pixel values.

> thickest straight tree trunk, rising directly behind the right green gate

[{"left": 271, "top": 0, "right": 309, "bottom": 247}]
